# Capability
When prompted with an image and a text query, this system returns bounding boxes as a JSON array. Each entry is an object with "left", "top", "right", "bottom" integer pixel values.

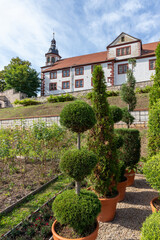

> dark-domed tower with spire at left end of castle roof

[{"left": 45, "top": 33, "right": 61, "bottom": 66}]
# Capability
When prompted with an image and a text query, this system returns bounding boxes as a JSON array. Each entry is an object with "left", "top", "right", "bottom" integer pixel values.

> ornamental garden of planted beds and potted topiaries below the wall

[{"left": 0, "top": 45, "right": 160, "bottom": 240}]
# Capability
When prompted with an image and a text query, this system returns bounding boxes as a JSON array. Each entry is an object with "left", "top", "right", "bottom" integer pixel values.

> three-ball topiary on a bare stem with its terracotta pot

[{"left": 52, "top": 101, "right": 101, "bottom": 240}]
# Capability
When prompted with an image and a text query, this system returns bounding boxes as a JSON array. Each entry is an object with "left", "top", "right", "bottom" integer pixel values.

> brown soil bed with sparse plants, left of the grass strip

[{"left": 0, "top": 158, "right": 59, "bottom": 211}]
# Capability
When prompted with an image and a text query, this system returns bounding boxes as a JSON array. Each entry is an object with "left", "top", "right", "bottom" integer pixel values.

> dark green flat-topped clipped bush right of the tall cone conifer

[{"left": 115, "top": 128, "right": 141, "bottom": 169}]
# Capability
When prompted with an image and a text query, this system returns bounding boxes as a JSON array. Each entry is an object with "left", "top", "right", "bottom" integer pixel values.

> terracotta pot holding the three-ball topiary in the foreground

[{"left": 51, "top": 220, "right": 99, "bottom": 240}]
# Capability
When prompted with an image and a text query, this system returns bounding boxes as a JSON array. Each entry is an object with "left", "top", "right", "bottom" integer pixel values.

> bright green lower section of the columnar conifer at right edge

[{"left": 148, "top": 99, "right": 160, "bottom": 156}]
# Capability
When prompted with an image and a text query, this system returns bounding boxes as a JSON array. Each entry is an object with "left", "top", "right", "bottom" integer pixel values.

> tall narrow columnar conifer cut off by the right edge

[{"left": 148, "top": 44, "right": 160, "bottom": 156}]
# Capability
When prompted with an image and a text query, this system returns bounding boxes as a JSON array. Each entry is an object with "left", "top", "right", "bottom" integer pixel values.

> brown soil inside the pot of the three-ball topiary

[{"left": 55, "top": 222, "right": 97, "bottom": 239}]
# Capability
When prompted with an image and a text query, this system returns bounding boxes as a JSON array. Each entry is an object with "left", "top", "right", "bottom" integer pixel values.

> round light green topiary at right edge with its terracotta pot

[{"left": 143, "top": 152, "right": 160, "bottom": 212}]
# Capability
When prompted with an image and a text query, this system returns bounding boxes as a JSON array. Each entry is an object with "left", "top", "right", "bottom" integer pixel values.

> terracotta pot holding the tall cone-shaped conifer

[{"left": 97, "top": 194, "right": 119, "bottom": 222}]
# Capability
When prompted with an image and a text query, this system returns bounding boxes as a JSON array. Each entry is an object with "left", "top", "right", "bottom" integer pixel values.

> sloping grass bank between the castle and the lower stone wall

[{"left": 0, "top": 93, "right": 149, "bottom": 119}]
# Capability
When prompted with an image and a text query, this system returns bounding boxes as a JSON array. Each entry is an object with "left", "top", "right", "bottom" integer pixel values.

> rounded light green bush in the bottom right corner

[{"left": 141, "top": 211, "right": 160, "bottom": 240}]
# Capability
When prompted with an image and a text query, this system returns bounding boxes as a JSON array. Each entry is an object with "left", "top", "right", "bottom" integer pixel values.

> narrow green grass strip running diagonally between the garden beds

[{"left": 0, "top": 175, "right": 71, "bottom": 236}]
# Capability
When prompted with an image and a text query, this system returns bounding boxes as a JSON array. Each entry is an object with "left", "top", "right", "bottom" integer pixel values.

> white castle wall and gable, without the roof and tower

[{"left": 42, "top": 33, "right": 158, "bottom": 95}]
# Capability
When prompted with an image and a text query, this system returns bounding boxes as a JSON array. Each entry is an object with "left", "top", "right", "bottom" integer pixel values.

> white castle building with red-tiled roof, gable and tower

[{"left": 41, "top": 32, "right": 160, "bottom": 96}]
